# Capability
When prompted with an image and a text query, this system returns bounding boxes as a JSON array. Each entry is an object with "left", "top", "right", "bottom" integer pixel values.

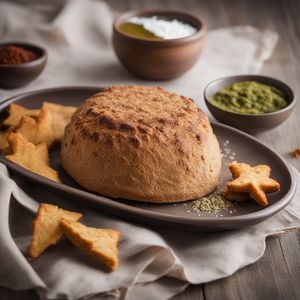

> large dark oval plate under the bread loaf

[{"left": 0, "top": 87, "right": 296, "bottom": 231}]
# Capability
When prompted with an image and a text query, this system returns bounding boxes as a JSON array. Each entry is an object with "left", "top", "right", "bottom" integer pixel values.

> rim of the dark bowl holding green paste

[{"left": 203, "top": 74, "right": 296, "bottom": 118}]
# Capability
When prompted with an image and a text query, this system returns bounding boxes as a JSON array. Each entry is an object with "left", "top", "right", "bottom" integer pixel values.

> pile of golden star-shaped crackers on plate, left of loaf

[{"left": 0, "top": 102, "right": 76, "bottom": 182}]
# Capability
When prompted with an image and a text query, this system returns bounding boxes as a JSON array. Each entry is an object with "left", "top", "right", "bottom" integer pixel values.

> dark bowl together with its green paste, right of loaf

[{"left": 204, "top": 75, "right": 296, "bottom": 133}]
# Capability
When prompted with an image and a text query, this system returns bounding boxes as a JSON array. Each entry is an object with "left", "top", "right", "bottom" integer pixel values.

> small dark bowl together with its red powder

[{"left": 0, "top": 42, "right": 48, "bottom": 88}]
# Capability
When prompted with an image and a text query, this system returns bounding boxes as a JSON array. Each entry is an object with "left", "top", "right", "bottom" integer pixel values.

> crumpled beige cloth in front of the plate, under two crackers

[{"left": 0, "top": 164, "right": 300, "bottom": 300}]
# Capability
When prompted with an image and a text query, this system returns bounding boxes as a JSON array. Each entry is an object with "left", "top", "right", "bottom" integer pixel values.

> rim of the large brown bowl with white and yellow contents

[{"left": 113, "top": 9, "right": 206, "bottom": 45}]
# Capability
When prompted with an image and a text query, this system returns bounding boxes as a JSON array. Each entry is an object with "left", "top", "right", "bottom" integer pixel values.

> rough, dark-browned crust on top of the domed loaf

[{"left": 67, "top": 86, "right": 211, "bottom": 150}]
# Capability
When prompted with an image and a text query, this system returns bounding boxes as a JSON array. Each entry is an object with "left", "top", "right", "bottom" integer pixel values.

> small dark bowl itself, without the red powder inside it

[{"left": 0, "top": 42, "right": 48, "bottom": 88}]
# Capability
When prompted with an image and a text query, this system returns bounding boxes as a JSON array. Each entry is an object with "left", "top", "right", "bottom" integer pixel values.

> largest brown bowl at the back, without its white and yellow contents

[{"left": 113, "top": 10, "right": 206, "bottom": 80}]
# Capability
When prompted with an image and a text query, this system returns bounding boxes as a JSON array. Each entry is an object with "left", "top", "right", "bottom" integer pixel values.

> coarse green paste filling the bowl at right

[{"left": 210, "top": 81, "right": 288, "bottom": 115}]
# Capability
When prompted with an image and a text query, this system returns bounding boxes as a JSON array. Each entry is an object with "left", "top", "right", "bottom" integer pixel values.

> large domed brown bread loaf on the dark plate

[{"left": 61, "top": 86, "right": 221, "bottom": 203}]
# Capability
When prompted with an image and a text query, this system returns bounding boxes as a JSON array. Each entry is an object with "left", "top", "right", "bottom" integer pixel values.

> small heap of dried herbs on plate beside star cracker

[{"left": 192, "top": 192, "right": 233, "bottom": 213}]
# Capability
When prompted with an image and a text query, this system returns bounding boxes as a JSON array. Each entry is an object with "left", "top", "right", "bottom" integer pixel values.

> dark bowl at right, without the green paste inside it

[{"left": 204, "top": 75, "right": 296, "bottom": 134}]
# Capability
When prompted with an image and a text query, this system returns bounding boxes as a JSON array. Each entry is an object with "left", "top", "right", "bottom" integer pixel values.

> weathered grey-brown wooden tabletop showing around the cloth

[{"left": 0, "top": 0, "right": 300, "bottom": 300}]
